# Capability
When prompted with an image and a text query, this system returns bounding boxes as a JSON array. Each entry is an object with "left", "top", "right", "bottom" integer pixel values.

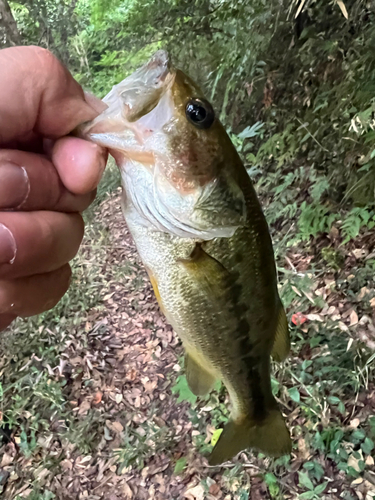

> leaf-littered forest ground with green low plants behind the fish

[{"left": 0, "top": 166, "right": 375, "bottom": 500}]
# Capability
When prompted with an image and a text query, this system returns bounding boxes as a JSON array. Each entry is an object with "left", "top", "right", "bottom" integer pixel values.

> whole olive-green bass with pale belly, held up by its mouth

[{"left": 80, "top": 50, "right": 292, "bottom": 465}]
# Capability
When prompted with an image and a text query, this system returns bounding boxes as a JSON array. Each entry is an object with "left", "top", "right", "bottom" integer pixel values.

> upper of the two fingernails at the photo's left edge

[{"left": 0, "top": 161, "right": 30, "bottom": 210}]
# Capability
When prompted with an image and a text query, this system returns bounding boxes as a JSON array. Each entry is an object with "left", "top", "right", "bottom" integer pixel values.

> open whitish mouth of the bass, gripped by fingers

[{"left": 81, "top": 50, "right": 176, "bottom": 156}]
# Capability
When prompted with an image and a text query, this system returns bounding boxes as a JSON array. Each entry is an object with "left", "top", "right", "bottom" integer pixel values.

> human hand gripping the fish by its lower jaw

[{"left": 0, "top": 47, "right": 107, "bottom": 331}]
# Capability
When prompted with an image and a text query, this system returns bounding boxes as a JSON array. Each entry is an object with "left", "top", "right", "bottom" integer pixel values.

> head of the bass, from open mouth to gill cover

[{"left": 82, "top": 50, "right": 244, "bottom": 239}]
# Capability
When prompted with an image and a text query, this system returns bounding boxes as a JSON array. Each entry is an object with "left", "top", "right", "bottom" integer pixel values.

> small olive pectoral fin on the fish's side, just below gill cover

[{"left": 178, "top": 243, "right": 230, "bottom": 297}]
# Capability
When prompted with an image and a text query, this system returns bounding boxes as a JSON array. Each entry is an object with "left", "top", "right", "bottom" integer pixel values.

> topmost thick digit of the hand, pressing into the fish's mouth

[{"left": 0, "top": 46, "right": 98, "bottom": 145}]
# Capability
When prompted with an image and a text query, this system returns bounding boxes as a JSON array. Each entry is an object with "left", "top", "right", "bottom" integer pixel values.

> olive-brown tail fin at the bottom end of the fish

[{"left": 208, "top": 409, "right": 292, "bottom": 465}]
